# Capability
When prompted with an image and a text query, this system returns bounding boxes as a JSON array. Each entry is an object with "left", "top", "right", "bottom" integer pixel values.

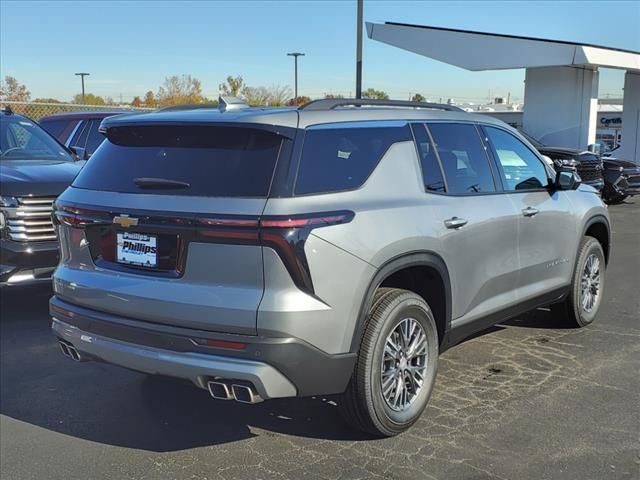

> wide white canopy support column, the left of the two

[{"left": 522, "top": 66, "right": 598, "bottom": 150}]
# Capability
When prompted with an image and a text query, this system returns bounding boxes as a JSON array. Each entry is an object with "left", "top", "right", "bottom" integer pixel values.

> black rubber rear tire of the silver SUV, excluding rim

[{"left": 339, "top": 288, "right": 439, "bottom": 437}]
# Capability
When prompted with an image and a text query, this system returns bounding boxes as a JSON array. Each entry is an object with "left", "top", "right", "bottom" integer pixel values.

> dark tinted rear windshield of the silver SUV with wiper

[{"left": 73, "top": 125, "right": 282, "bottom": 197}]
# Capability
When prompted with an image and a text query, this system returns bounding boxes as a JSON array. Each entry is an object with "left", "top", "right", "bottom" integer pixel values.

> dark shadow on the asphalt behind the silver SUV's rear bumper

[{"left": 0, "top": 289, "right": 372, "bottom": 452}]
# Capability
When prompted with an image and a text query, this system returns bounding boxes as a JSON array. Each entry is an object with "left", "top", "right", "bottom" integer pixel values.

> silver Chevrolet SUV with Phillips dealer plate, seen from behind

[{"left": 50, "top": 99, "right": 610, "bottom": 436}]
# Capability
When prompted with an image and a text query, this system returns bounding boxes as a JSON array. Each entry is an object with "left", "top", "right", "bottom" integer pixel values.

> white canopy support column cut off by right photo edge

[{"left": 614, "top": 70, "right": 640, "bottom": 165}]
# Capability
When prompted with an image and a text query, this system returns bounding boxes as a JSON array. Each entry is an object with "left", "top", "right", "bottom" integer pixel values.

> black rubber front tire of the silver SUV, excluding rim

[{"left": 551, "top": 237, "right": 606, "bottom": 327}]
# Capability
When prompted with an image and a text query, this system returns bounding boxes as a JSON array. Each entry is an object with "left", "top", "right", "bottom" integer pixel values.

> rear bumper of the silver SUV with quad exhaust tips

[{"left": 50, "top": 296, "right": 355, "bottom": 403}]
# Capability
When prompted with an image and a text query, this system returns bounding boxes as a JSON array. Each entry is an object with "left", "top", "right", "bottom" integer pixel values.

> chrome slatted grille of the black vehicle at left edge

[{"left": 7, "top": 197, "right": 56, "bottom": 242}]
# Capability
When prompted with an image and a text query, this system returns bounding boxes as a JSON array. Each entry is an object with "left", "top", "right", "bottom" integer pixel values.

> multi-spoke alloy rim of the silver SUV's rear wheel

[{"left": 380, "top": 318, "right": 428, "bottom": 411}]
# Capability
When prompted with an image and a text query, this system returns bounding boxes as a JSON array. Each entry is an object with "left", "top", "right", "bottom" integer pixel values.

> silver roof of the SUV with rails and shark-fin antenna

[{"left": 102, "top": 102, "right": 505, "bottom": 129}]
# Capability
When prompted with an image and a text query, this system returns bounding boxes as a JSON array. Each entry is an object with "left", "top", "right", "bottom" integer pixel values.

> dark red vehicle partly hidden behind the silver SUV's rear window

[{"left": 39, "top": 110, "right": 131, "bottom": 160}]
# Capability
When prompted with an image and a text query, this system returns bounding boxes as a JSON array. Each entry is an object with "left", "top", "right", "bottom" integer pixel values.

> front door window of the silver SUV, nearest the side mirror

[{"left": 484, "top": 127, "right": 549, "bottom": 191}]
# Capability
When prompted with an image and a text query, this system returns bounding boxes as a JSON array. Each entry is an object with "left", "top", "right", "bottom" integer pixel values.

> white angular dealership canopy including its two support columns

[{"left": 367, "top": 22, "right": 640, "bottom": 163}]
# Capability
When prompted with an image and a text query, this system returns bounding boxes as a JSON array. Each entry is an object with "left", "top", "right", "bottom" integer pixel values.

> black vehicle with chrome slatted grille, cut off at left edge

[{"left": 0, "top": 109, "right": 85, "bottom": 286}]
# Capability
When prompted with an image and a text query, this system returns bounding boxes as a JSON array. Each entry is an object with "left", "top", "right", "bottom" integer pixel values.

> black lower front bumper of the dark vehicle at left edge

[{"left": 0, "top": 239, "right": 59, "bottom": 286}]
